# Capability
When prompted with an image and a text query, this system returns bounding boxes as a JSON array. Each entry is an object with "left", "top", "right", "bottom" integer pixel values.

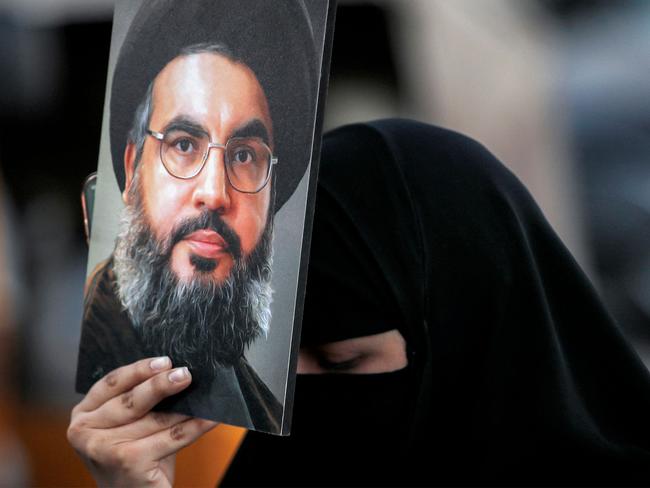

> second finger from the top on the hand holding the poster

[{"left": 87, "top": 367, "right": 192, "bottom": 429}]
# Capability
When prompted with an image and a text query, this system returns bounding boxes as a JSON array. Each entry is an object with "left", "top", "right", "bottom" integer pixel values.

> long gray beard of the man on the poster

[{"left": 113, "top": 181, "right": 273, "bottom": 375}]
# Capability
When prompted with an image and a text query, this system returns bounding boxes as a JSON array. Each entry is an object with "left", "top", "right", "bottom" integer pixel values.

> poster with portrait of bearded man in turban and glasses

[{"left": 77, "top": 0, "right": 334, "bottom": 434}]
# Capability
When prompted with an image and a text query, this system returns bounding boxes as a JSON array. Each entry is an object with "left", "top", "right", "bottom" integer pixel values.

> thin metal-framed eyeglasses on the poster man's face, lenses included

[{"left": 147, "top": 129, "right": 278, "bottom": 193}]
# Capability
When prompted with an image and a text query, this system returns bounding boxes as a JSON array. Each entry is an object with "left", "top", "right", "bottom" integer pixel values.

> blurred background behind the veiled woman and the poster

[{"left": 0, "top": 0, "right": 650, "bottom": 486}]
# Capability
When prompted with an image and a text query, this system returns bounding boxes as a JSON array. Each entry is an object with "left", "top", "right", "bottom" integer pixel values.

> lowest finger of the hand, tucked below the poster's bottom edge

[{"left": 133, "top": 418, "right": 219, "bottom": 460}]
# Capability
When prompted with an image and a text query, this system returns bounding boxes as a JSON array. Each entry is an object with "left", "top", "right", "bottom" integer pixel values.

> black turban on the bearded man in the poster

[{"left": 110, "top": 0, "right": 318, "bottom": 210}]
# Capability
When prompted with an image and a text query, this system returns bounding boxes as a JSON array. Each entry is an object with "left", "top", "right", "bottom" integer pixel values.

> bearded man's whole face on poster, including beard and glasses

[{"left": 114, "top": 52, "right": 273, "bottom": 373}]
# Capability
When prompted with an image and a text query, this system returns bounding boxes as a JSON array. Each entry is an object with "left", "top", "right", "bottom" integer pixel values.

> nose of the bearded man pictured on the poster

[{"left": 193, "top": 147, "right": 230, "bottom": 214}]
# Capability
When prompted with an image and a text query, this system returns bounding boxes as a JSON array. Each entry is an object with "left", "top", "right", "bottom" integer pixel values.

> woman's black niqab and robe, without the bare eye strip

[{"left": 224, "top": 120, "right": 650, "bottom": 485}]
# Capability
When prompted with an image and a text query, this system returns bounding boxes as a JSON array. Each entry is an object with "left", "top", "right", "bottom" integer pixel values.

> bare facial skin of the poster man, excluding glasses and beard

[{"left": 123, "top": 53, "right": 272, "bottom": 283}]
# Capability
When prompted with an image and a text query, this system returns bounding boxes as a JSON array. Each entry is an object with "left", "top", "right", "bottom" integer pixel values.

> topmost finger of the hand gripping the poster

[{"left": 73, "top": 356, "right": 172, "bottom": 415}]
